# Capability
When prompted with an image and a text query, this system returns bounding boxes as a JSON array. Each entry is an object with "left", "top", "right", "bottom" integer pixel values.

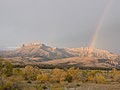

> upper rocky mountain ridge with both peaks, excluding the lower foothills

[{"left": 0, "top": 43, "right": 118, "bottom": 59}]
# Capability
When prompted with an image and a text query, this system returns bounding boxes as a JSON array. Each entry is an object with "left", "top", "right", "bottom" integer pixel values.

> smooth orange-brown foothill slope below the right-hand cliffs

[{"left": 39, "top": 57, "right": 120, "bottom": 68}]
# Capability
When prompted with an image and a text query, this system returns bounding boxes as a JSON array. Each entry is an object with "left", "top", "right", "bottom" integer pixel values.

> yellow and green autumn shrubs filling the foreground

[{"left": 0, "top": 59, "right": 120, "bottom": 90}]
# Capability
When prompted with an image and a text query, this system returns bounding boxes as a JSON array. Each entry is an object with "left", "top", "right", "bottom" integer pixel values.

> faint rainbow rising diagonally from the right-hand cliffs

[{"left": 88, "top": 0, "right": 113, "bottom": 48}]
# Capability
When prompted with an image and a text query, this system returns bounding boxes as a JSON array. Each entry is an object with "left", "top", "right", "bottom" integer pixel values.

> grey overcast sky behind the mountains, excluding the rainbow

[{"left": 0, "top": 0, "right": 120, "bottom": 53}]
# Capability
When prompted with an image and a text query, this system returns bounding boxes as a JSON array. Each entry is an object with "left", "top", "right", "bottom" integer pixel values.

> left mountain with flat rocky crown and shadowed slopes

[{"left": 3, "top": 43, "right": 74, "bottom": 59}]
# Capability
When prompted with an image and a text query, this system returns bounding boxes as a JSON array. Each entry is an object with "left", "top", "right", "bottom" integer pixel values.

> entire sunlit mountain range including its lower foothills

[{"left": 0, "top": 43, "right": 120, "bottom": 67}]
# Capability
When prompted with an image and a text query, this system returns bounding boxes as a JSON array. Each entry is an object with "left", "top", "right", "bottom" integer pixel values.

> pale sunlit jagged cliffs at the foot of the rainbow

[{"left": 65, "top": 47, "right": 117, "bottom": 59}]
